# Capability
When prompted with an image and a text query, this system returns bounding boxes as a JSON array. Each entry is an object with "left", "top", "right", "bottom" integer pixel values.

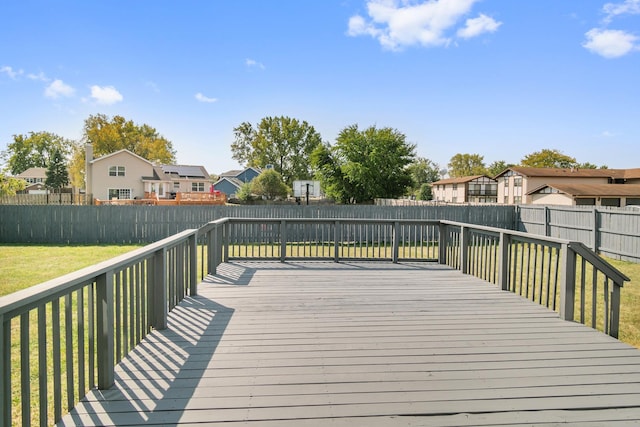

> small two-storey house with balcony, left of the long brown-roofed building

[{"left": 431, "top": 175, "right": 498, "bottom": 203}]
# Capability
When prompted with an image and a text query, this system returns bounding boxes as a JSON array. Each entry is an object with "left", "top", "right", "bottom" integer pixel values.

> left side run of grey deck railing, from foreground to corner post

[{"left": 0, "top": 230, "right": 197, "bottom": 426}]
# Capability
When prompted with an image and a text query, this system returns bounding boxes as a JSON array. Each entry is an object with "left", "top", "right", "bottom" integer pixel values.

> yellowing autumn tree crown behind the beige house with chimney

[{"left": 83, "top": 114, "right": 176, "bottom": 164}]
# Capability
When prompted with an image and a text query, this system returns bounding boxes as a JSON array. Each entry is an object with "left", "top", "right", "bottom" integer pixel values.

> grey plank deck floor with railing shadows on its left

[{"left": 61, "top": 262, "right": 640, "bottom": 427}]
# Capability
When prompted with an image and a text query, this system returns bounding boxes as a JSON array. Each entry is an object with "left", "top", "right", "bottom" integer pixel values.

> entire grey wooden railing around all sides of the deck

[{"left": 0, "top": 218, "right": 629, "bottom": 426}]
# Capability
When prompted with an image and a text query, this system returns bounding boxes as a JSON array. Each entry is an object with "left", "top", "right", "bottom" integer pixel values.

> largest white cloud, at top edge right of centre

[{"left": 347, "top": 0, "right": 501, "bottom": 50}]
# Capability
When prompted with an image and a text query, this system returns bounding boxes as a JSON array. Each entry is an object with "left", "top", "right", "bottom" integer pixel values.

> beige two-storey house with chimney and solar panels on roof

[{"left": 86, "top": 144, "right": 213, "bottom": 205}]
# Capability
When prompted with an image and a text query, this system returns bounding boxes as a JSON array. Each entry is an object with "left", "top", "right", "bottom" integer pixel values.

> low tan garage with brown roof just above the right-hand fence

[{"left": 527, "top": 184, "right": 640, "bottom": 207}]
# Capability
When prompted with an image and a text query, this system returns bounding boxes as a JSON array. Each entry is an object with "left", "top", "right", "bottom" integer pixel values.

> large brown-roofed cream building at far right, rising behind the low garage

[{"left": 495, "top": 166, "right": 640, "bottom": 204}]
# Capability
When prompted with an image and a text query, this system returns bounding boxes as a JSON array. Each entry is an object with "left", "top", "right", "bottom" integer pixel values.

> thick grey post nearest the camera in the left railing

[{"left": 96, "top": 271, "right": 115, "bottom": 390}]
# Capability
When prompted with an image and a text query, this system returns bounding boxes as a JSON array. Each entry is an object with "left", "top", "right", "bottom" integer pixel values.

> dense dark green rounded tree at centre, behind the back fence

[{"left": 312, "top": 125, "right": 415, "bottom": 203}]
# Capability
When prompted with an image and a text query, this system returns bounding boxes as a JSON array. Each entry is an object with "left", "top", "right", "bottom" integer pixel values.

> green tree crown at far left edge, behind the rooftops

[{"left": 1, "top": 132, "right": 73, "bottom": 175}]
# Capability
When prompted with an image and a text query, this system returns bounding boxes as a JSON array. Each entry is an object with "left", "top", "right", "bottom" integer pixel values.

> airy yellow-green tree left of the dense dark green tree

[{"left": 231, "top": 116, "right": 322, "bottom": 186}]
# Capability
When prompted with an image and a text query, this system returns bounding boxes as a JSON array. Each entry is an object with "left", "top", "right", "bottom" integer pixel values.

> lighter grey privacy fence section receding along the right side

[{"left": 517, "top": 205, "right": 640, "bottom": 262}]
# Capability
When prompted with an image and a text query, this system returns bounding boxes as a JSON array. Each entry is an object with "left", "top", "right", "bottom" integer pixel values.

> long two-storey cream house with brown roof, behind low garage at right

[{"left": 495, "top": 166, "right": 640, "bottom": 206}]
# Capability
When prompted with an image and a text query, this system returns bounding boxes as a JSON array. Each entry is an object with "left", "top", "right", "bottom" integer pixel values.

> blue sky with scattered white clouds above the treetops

[{"left": 0, "top": 0, "right": 640, "bottom": 173}]
